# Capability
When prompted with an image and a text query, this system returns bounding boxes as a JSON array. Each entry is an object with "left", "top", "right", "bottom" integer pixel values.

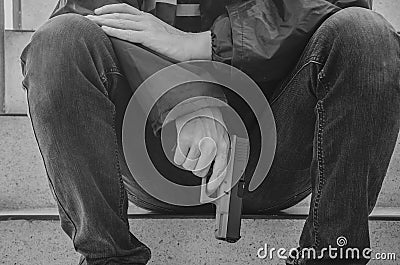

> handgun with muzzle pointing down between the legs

[{"left": 200, "top": 135, "right": 249, "bottom": 243}]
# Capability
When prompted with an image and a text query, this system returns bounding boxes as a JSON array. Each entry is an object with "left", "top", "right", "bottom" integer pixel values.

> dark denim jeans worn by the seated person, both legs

[{"left": 21, "top": 8, "right": 400, "bottom": 264}]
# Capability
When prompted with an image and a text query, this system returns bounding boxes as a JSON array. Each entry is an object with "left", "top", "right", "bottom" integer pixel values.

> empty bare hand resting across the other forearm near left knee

[{"left": 86, "top": 4, "right": 211, "bottom": 62}]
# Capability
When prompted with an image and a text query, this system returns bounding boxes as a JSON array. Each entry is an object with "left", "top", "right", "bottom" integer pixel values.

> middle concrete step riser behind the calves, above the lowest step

[{"left": 0, "top": 116, "right": 400, "bottom": 210}]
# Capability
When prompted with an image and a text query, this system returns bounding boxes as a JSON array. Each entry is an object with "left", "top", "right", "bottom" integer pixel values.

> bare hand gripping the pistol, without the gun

[{"left": 174, "top": 108, "right": 230, "bottom": 194}]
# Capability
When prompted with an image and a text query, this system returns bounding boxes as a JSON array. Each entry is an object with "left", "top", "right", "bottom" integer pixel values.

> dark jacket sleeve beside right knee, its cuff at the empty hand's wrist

[{"left": 211, "top": 0, "right": 372, "bottom": 82}]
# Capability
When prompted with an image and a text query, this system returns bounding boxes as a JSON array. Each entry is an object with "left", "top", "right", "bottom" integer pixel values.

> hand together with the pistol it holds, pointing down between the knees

[{"left": 174, "top": 105, "right": 249, "bottom": 243}]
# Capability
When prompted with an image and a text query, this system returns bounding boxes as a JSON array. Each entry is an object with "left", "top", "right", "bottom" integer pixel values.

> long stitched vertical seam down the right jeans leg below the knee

[{"left": 313, "top": 100, "right": 325, "bottom": 248}]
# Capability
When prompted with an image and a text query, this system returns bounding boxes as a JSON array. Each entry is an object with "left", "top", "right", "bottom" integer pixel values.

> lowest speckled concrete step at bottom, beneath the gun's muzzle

[{"left": 0, "top": 219, "right": 400, "bottom": 265}]
